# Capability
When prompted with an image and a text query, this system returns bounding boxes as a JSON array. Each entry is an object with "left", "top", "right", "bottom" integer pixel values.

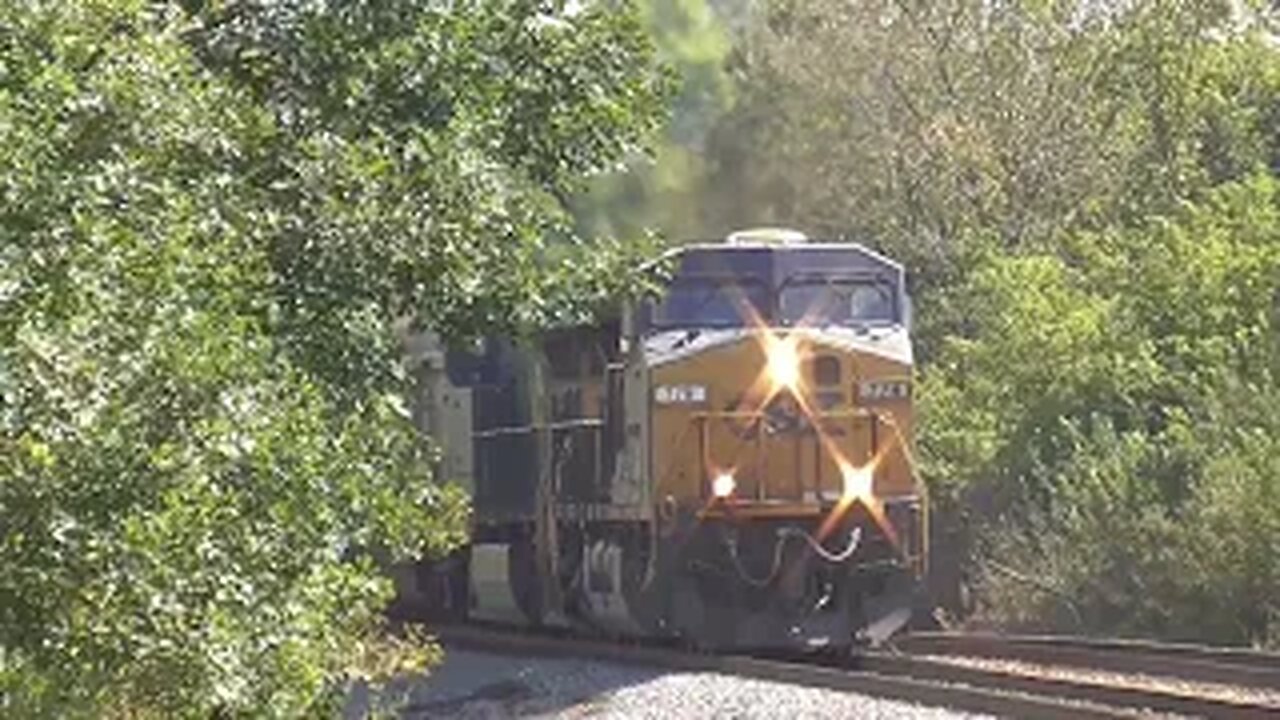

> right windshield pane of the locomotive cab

[{"left": 778, "top": 278, "right": 897, "bottom": 325}]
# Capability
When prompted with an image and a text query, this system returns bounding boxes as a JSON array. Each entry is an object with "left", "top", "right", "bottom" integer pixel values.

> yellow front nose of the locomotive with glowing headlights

[{"left": 686, "top": 329, "right": 876, "bottom": 504}]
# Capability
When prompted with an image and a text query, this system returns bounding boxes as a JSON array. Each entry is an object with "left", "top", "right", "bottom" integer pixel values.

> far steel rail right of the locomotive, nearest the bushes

[{"left": 893, "top": 633, "right": 1280, "bottom": 691}]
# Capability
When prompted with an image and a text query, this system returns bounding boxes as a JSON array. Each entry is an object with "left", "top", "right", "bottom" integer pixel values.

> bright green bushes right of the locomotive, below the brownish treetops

[{"left": 925, "top": 176, "right": 1280, "bottom": 644}]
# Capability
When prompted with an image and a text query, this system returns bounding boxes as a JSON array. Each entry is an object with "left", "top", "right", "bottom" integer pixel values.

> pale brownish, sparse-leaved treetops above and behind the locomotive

[{"left": 707, "top": 0, "right": 1280, "bottom": 288}]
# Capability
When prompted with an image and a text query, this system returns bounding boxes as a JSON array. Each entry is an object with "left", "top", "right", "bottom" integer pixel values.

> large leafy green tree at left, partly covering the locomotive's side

[{"left": 0, "top": 0, "right": 666, "bottom": 717}]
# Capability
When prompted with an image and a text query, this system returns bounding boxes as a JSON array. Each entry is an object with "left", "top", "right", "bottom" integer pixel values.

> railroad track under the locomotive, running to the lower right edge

[{"left": 438, "top": 625, "right": 1280, "bottom": 720}]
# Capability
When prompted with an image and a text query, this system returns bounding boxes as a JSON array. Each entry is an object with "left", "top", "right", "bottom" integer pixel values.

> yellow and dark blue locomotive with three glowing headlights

[{"left": 399, "top": 229, "right": 927, "bottom": 650}]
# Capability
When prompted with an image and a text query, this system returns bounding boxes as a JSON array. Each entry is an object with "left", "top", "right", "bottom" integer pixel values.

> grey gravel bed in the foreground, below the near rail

[{"left": 384, "top": 648, "right": 984, "bottom": 720}]
